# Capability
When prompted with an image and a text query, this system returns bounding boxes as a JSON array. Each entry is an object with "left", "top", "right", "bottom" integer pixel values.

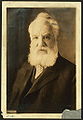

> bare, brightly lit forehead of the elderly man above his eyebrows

[{"left": 30, "top": 21, "right": 52, "bottom": 35}]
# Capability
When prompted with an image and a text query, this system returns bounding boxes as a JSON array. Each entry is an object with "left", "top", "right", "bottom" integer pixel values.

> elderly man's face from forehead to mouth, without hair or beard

[{"left": 31, "top": 23, "right": 55, "bottom": 55}]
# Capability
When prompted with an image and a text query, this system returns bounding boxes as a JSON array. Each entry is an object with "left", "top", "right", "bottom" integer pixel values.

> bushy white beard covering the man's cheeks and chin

[{"left": 28, "top": 44, "right": 58, "bottom": 67}]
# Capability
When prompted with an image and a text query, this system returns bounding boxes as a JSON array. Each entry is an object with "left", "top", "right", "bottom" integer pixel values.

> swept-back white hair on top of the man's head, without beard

[{"left": 28, "top": 12, "right": 59, "bottom": 40}]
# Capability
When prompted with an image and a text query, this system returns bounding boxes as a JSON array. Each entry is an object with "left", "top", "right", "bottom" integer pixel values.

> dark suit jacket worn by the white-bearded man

[{"left": 9, "top": 55, "right": 76, "bottom": 113}]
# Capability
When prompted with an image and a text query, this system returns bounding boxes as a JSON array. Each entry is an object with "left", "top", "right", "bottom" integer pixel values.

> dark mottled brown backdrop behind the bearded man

[{"left": 7, "top": 8, "right": 76, "bottom": 106}]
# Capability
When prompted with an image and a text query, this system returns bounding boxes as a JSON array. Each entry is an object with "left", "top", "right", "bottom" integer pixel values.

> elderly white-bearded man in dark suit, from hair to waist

[{"left": 10, "top": 12, "right": 75, "bottom": 113}]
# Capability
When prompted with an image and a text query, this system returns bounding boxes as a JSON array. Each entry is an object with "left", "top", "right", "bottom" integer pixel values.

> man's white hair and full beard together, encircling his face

[{"left": 28, "top": 12, "right": 59, "bottom": 67}]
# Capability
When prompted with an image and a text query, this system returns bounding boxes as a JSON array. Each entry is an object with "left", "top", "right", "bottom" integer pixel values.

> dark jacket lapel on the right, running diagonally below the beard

[{"left": 25, "top": 57, "right": 61, "bottom": 96}]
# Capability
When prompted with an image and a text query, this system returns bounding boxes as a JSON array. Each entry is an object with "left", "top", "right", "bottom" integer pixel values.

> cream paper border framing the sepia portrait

[{"left": 1, "top": 1, "right": 81, "bottom": 119}]
